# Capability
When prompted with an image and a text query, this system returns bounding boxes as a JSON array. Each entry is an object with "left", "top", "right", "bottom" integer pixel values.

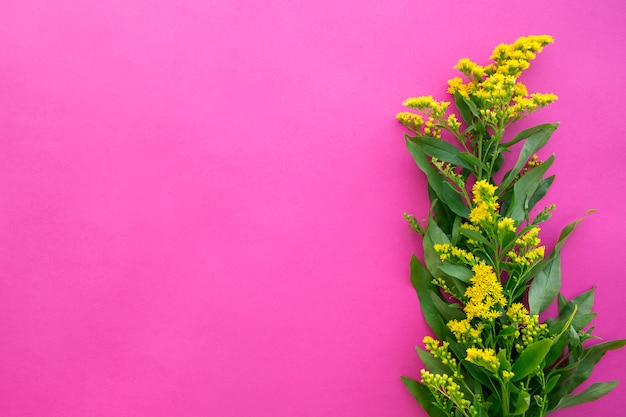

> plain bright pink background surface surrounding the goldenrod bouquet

[{"left": 0, "top": 0, "right": 626, "bottom": 417}]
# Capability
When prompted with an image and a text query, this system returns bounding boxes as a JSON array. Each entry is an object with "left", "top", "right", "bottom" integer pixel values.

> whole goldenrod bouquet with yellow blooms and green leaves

[{"left": 397, "top": 35, "right": 626, "bottom": 417}]
